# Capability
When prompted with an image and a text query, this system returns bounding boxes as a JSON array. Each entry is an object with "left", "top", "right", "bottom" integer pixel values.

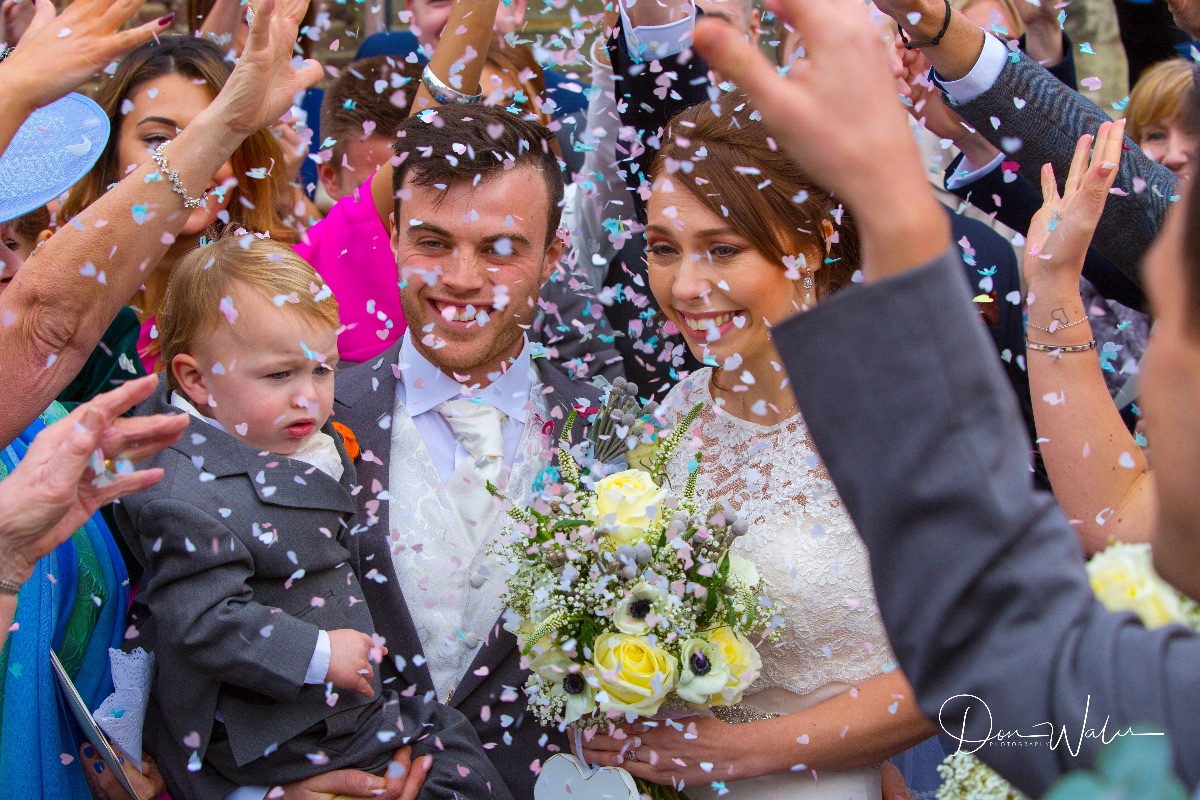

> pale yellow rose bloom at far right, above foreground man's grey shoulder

[{"left": 1087, "top": 543, "right": 1183, "bottom": 627}]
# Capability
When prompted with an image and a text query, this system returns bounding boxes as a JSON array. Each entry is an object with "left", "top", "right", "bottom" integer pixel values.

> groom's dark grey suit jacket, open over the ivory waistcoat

[{"left": 334, "top": 342, "right": 600, "bottom": 800}]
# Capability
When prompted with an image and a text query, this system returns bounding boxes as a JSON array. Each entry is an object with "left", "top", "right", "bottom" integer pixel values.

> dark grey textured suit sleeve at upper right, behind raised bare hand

[{"left": 940, "top": 44, "right": 1178, "bottom": 285}]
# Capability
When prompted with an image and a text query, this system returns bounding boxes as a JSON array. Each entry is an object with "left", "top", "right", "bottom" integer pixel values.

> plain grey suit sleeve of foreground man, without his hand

[{"left": 775, "top": 252, "right": 1200, "bottom": 796}]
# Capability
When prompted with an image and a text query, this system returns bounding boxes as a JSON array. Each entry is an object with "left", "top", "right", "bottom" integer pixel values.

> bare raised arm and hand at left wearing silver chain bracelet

[{"left": 0, "top": 0, "right": 320, "bottom": 441}]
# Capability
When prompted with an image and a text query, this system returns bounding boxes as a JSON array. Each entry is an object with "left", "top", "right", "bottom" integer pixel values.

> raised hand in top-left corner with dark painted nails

[{"left": 0, "top": 0, "right": 175, "bottom": 114}]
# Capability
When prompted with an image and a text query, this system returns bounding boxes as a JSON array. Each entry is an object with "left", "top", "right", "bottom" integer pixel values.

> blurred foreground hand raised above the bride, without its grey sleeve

[{"left": 695, "top": 0, "right": 949, "bottom": 279}]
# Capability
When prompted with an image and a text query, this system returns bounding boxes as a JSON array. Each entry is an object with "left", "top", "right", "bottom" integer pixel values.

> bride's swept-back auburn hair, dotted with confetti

[{"left": 650, "top": 91, "right": 859, "bottom": 301}]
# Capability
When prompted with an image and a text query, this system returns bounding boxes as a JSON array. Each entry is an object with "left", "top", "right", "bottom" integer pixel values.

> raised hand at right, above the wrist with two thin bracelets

[{"left": 1024, "top": 120, "right": 1124, "bottom": 294}]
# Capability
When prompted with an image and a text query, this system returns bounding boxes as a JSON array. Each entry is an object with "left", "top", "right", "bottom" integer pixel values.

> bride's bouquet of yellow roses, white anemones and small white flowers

[{"left": 489, "top": 387, "right": 781, "bottom": 789}]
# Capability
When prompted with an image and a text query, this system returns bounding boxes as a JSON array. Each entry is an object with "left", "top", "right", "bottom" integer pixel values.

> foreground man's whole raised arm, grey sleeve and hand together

[{"left": 696, "top": 0, "right": 1200, "bottom": 794}]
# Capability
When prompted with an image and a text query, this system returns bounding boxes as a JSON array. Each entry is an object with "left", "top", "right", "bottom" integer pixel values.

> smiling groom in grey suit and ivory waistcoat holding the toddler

[{"left": 335, "top": 106, "right": 599, "bottom": 800}]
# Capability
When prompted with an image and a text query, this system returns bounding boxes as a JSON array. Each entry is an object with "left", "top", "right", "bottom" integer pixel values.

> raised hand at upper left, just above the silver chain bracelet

[{"left": 210, "top": 0, "right": 322, "bottom": 137}]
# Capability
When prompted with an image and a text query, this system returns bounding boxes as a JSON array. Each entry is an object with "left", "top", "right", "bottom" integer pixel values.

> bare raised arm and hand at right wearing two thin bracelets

[{"left": 1025, "top": 120, "right": 1157, "bottom": 555}]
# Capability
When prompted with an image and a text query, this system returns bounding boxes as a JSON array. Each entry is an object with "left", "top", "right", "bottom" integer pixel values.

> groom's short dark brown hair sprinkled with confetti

[{"left": 391, "top": 103, "right": 563, "bottom": 247}]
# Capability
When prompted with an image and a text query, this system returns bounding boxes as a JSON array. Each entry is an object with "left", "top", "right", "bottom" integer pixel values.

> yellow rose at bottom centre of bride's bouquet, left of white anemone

[{"left": 593, "top": 633, "right": 677, "bottom": 717}]
